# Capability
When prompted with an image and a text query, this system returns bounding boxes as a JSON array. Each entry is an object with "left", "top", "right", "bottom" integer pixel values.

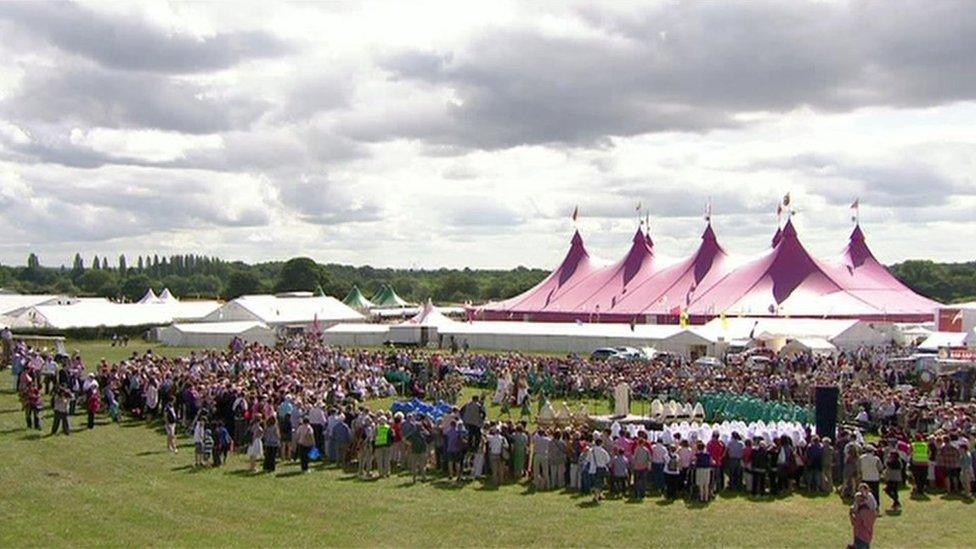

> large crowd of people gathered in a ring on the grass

[{"left": 3, "top": 330, "right": 974, "bottom": 532}]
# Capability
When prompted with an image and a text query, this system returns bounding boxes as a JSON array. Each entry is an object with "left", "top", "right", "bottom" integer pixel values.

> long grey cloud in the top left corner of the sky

[{"left": 0, "top": 2, "right": 290, "bottom": 73}]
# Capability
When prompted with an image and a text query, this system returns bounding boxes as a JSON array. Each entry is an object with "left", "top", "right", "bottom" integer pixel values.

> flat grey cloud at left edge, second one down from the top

[{"left": 0, "top": 67, "right": 268, "bottom": 134}]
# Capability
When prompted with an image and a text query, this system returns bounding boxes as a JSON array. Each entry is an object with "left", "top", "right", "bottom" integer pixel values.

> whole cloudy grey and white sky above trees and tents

[{"left": 0, "top": 0, "right": 976, "bottom": 267}]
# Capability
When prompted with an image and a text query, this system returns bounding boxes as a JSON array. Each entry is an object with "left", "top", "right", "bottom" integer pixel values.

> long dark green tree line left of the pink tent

[{"left": 0, "top": 253, "right": 548, "bottom": 303}]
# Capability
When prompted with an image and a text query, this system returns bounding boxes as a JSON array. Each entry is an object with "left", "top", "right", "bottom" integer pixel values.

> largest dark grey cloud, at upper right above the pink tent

[{"left": 360, "top": 2, "right": 976, "bottom": 149}]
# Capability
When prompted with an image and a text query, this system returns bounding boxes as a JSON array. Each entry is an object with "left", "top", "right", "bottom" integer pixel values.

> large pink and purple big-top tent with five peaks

[{"left": 483, "top": 220, "right": 936, "bottom": 322}]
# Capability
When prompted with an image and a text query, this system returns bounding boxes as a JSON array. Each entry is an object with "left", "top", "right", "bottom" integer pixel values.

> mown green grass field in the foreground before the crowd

[{"left": 0, "top": 343, "right": 976, "bottom": 547}]
